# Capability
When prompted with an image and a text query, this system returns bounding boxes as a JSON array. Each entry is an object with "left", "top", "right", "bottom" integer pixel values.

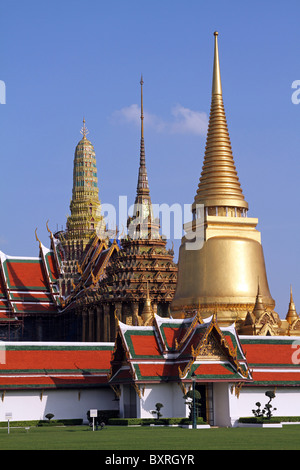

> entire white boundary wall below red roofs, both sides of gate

[{"left": 0, "top": 382, "right": 300, "bottom": 426}]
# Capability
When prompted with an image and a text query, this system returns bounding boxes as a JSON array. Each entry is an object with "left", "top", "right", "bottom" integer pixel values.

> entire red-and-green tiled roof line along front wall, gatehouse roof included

[{"left": 0, "top": 315, "right": 300, "bottom": 395}]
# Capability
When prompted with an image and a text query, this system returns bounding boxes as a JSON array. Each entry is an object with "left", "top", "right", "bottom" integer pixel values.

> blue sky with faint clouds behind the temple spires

[{"left": 0, "top": 0, "right": 300, "bottom": 317}]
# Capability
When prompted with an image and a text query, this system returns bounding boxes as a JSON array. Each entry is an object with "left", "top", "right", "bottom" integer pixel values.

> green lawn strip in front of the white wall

[{"left": 0, "top": 425, "right": 300, "bottom": 451}]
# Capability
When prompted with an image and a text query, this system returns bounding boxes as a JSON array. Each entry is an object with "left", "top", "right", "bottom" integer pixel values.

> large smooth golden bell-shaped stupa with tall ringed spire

[{"left": 171, "top": 32, "right": 275, "bottom": 325}]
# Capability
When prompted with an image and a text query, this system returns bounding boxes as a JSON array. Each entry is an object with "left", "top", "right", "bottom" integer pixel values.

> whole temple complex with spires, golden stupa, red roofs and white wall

[{"left": 0, "top": 33, "right": 300, "bottom": 428}]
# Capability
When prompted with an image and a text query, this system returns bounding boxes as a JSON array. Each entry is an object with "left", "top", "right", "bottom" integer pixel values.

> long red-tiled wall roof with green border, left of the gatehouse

[{"left": 0, "top": 342, "right": 113, "bottom": 391}]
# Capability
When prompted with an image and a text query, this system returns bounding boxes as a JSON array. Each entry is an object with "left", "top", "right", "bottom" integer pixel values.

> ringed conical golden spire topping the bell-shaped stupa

[{"left": 195, "top": 32, "right": 248, "bottom": 215}]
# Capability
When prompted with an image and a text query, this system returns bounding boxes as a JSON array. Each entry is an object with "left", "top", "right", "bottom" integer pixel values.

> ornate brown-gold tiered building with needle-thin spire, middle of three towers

[{"left": 99, "top": 78, "right": 177, "bottom": 325}]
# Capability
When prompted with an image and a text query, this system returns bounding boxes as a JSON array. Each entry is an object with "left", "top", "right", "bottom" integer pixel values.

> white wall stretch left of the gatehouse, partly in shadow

[{"left": 0, "top": 388, "right": 118, "bottom": 422}]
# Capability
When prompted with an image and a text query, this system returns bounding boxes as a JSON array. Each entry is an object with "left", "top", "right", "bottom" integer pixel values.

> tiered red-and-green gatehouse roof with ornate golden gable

[{"left": 110, "top": 315, "right": 251, "bottom": 384}]
